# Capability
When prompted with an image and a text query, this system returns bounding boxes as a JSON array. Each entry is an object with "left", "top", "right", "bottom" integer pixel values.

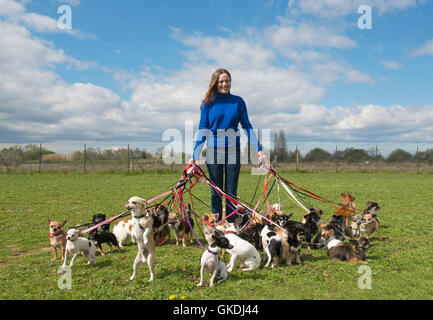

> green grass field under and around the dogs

[{"left": 0, "top": 172, "right": 433, "bottom": 300}]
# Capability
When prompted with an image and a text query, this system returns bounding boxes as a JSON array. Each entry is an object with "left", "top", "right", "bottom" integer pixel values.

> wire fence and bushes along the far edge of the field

[{"left": 0, "top": 144, "right": 433, "bottom": 174}]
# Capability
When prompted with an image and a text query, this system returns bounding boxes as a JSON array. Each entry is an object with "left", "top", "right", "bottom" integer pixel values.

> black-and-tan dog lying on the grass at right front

[{"left": 326, "top": 237, "right": 370, "bottom": 264}]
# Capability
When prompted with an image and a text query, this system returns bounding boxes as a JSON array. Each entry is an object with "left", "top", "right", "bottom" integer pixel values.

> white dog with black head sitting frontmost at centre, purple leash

[{"left": 197, "top": 232, "right": 233, "bottom": 287}]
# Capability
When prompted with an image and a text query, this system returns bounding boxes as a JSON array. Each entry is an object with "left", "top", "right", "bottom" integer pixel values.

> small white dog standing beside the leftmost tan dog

[{"left": 62, "top": 229, "right": 96, "bottom": 270}]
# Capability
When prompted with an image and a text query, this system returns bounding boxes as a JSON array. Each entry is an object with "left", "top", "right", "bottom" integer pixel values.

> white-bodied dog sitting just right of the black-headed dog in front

[{"left": 225, "top": 233, "right": 262, "bottom": 272}]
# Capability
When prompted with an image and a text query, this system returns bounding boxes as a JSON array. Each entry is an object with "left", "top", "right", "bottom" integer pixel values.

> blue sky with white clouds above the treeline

[{"left": 0, "top": 0, "right": 433, "bottom": 155}]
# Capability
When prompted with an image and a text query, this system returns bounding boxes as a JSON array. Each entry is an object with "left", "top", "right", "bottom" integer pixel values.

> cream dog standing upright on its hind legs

[{"left": 125, "top": 196, "right": 155, "bottom": 282}]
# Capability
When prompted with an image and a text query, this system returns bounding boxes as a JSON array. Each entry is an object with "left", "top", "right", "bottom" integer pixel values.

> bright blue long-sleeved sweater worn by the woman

[{"left": 193, "top": 93, "right": 262, "bottom": 160}]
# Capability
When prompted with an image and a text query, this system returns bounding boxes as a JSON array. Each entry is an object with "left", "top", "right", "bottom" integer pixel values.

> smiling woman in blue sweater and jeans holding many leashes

[{"left": 190, "top": 69, "right": 266, "bottom": 222}]
